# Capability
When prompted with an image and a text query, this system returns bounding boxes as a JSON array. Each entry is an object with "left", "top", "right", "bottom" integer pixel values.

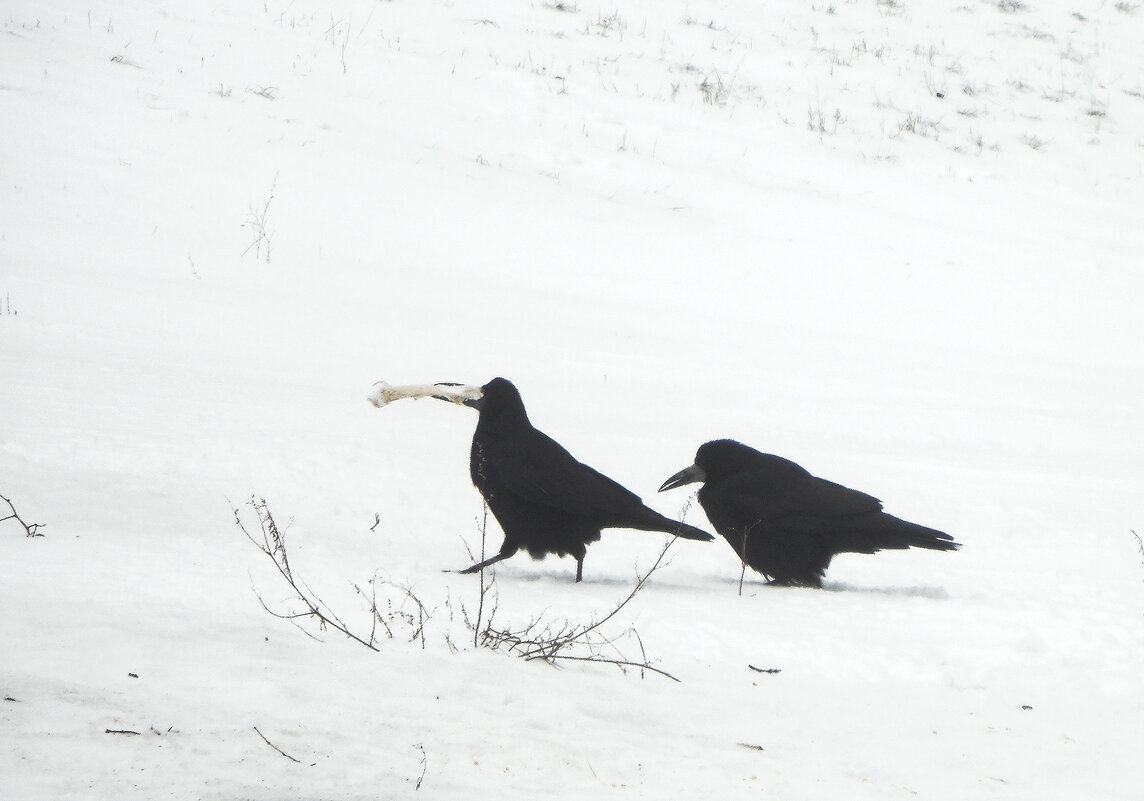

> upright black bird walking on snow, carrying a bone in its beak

[{"left": 445, "top": 378, "right": 715, "bottom": 581}]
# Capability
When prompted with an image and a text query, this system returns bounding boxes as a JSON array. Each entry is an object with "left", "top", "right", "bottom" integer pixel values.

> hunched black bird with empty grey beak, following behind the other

[{"left": 659, "top": 439, "right": 961, "bottom": 587}]
